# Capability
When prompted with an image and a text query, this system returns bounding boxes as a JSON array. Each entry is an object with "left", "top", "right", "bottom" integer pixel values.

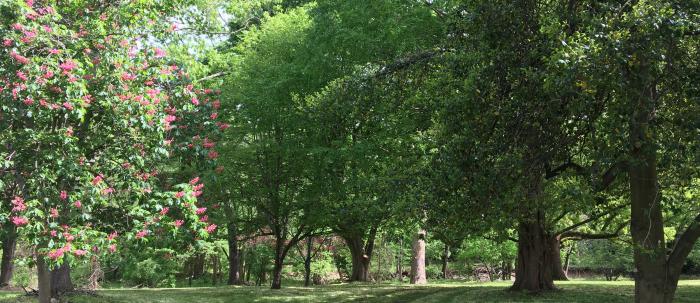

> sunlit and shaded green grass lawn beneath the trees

[{"left": 0, "top": 280, "right": 700, "bottom": 303}]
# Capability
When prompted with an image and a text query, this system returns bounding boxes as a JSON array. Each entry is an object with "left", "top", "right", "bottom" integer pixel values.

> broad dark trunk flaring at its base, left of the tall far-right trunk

[{"left": 511, "top": 211, "right": 554, "bottom": 292}]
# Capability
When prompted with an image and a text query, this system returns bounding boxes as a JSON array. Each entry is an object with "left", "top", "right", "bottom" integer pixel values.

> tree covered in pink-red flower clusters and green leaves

[{"left": 0, "top": 0, "right": 219, "bottom": 302}]
